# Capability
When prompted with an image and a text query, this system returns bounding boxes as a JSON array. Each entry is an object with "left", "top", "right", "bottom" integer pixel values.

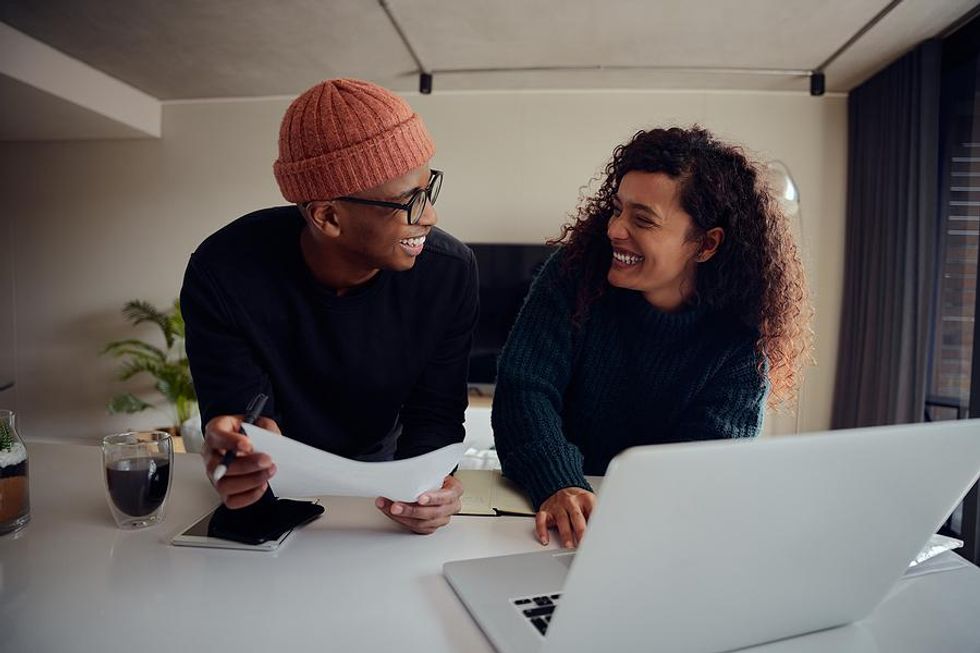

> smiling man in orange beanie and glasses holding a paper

[{"left": 180, "top": 79, "right": 478, "bottom": 533}]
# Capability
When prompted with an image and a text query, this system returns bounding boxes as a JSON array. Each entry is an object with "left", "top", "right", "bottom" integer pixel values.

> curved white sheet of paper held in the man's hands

[{"left": 244, "top": 424, "right": 466, "bottom": 503}]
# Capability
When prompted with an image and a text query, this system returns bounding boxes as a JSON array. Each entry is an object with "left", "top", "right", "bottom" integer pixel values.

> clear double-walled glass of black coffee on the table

[{"left": 102, "top": 431, "right": 174, "bottom": 528}]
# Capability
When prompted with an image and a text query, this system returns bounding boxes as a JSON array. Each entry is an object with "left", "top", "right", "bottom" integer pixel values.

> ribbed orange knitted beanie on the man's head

[{"left": 273, "top": 79, "right": 435, "bottom": 204}]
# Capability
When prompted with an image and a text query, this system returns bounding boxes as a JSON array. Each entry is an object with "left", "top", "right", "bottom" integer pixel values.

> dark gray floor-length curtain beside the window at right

[{"left": 832, "top": 40, "right": 942, "bottom": 428}]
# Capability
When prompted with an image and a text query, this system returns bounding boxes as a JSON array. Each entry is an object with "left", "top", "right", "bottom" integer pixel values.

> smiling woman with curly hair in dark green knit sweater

[{"left": 492, "top": 127, "right": 813, "bottom": 547}]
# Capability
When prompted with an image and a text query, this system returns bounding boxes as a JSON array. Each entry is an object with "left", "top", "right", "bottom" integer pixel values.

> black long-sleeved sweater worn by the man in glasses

[{"left": 180, "top": 206, "right": 478, "bottom": 460}]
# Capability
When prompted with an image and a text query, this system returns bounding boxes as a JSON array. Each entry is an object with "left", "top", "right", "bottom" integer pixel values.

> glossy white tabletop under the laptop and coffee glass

[{"left": 0, "top": 443, "right": 980, "bottom": 653}]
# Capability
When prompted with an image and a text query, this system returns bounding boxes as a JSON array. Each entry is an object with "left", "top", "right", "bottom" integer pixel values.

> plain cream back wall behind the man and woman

[{"left": 0, "top": 91, "right": 847, "bottom": 439}]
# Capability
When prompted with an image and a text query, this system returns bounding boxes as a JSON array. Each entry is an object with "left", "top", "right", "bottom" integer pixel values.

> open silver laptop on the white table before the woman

[{"left": 443, "top": 420, "right": 980, "bottom": 653}]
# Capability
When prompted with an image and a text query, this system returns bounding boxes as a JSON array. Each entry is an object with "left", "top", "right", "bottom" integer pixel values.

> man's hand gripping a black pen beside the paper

[{"left": 201, "top": 415, "right": 282, "bottom": 509}]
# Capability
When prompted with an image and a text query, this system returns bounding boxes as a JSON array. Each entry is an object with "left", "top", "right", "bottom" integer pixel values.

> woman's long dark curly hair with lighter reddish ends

[{"left": 549, "top": 125, "right": 813, "bottom": 408}]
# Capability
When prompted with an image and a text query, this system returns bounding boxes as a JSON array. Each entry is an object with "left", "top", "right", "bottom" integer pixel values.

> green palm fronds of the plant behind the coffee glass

[{"left": 102, "top": 300, "right": 197, "bottom": 435}]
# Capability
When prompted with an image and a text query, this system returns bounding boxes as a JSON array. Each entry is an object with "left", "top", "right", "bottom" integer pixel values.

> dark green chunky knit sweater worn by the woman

[{"left": 492, "top": 250, "right": 767, "bottom": 508}]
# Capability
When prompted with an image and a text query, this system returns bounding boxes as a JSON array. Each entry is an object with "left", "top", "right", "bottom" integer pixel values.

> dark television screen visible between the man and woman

[{"left": 468, "top": 243, "right": 554, "bottom": 392}]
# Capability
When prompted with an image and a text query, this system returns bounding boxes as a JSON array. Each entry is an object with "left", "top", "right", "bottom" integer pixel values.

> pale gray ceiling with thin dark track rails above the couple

[{"left": 0, "top": 0, "right": 976, "bottom": 137}]
